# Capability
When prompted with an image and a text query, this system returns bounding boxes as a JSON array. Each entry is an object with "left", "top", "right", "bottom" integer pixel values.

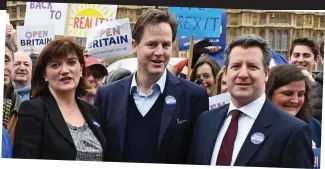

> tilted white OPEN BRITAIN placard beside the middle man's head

[{"left": 86, "top": 18, "right": 132, "bottom": 60}]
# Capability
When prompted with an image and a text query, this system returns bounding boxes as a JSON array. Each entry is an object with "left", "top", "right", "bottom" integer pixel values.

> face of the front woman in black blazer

[{"left": 44, "top": 54, "right": 82, "bottom": 93}]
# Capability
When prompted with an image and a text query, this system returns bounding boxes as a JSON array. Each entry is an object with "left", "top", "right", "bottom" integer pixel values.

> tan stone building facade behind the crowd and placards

[{"left": 7, "top": 1, "right": 325, "bottom": 58}]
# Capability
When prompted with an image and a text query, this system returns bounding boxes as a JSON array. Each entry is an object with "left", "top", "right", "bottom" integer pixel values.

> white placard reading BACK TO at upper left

[{"left": 24, "top": 2, "right": 68, "bottom": 35}]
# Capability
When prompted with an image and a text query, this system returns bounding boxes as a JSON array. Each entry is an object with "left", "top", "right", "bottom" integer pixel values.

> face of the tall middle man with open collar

[{"left": 133, "top": 22, "right": 173, "bottom": 76}]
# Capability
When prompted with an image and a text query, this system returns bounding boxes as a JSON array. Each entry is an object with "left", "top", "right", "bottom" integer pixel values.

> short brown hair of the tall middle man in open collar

[{"left": 132, "top": 9, "right": 178, "bottom": 43}]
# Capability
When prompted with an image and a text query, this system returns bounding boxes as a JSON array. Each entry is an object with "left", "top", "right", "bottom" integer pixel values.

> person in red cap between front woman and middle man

[{"left": 80, "top": 53, "right": 108, "bottom": 104}]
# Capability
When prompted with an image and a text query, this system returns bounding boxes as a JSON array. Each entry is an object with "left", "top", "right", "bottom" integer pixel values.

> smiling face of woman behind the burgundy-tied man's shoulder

[{"left": 271, "top": 80, "right": 306, "bottom": 116}]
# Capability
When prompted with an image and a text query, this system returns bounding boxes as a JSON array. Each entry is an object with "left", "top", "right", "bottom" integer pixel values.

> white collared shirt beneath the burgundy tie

[{"left": 211, "top": 94, "right": 266, "bottom": 166}]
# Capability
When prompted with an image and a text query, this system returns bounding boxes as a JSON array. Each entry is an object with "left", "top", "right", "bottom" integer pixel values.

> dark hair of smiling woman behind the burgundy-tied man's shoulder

[{"left": 266, "top": 64, "right": 313, "bottom": 120}]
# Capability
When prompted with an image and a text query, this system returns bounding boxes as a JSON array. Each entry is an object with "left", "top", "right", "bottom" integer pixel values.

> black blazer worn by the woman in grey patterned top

[{"left": 13, "top": 96, "right": 106, "bottom": 160}]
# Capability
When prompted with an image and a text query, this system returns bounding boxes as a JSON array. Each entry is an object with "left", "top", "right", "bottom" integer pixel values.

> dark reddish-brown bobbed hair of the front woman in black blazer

[{"left": 31, "top": 37, "right": 88, "bottom": 98}]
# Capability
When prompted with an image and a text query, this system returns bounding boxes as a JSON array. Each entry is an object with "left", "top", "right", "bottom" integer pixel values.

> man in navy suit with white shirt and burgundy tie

[{"left": 188, "top": 35, "right": 314, "bottom": 168}]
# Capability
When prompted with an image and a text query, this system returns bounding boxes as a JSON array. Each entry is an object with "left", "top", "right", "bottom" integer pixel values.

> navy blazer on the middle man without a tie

[{"left": 95, "top": 72, "right": 209, "bottom": 164}]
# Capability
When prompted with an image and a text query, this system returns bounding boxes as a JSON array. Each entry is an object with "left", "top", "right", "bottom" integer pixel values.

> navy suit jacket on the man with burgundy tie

[{"left": 188, "top": 99, "right": 314, "bottom": 168}]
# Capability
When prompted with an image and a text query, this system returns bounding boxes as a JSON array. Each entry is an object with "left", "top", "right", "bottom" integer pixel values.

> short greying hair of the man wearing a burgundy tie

[{"left": 225, "top": 34, "right": 272, "bottom": 69}]
